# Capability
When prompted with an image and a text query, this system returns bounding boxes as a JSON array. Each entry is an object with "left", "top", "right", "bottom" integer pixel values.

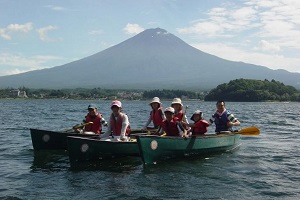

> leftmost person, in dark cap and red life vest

[{"left": 74, "top": 104, "right": 107, "bottom": 134}]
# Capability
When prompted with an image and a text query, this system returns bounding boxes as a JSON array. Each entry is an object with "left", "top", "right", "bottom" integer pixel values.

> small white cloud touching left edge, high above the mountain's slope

[{"left": 0, "top": 22, "right": 33, "bottom": 40}]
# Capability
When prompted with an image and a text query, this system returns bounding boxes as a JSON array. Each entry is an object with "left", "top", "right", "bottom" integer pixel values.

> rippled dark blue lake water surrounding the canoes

[{"left": 0, "top": 100, "right": 300, "bottom": 200}]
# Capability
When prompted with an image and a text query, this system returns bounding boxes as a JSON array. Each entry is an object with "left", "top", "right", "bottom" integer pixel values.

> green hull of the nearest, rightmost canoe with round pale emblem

[{"left": 136, "top": 134, "right": 240, "bottom": 165}]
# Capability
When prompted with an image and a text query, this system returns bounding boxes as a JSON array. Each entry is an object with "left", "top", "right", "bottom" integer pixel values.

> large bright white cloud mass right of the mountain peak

[{"left": 177, "top": 0, "right": 300, "bottom": 72}]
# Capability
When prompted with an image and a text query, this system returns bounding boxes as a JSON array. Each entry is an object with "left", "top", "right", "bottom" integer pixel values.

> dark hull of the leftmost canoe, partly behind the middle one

[{"left": 30, "top": 129, "right": 97, "bottom": 150}]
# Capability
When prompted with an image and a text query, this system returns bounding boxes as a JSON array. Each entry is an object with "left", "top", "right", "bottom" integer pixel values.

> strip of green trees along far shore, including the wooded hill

[{"left": 0, "top": 79, "right": 300, "bottom": 102}]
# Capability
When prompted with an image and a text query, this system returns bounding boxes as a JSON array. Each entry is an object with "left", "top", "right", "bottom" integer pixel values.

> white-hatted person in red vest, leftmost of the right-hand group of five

[{"left": 143, "top": 97, "right": 166, "bottom": 130}]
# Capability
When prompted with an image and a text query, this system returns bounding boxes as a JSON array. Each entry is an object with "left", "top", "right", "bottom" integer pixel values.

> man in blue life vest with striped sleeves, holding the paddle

[{"left": 209, "top": 101, "right": 240, "bottom": 133}]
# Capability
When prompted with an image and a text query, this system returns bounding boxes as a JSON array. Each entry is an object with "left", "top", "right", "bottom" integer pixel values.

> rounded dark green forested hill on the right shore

[{"left": 204, "top": 79, "right": 300, "bottom": 102}]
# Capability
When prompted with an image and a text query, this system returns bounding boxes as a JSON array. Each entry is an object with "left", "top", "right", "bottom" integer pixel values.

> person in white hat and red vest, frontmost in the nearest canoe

[{"left": 157, "top": 107, "right": 188, "bottom": 138}]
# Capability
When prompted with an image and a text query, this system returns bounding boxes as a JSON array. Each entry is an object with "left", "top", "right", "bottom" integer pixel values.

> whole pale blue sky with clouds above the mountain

[{"left": 0, "top": 0, "right": 300, "bottom": 76}]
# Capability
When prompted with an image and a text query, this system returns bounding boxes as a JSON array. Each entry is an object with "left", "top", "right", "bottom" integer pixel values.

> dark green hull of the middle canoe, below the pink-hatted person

[{"left": 67, "top": 136, "right": 139, "bottom": 163}]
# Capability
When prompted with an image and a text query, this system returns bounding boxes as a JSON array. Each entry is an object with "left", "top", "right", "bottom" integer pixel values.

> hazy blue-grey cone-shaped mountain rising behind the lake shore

[{"left": 0, "top": 28, "right": 300, "bottom": 89}]
